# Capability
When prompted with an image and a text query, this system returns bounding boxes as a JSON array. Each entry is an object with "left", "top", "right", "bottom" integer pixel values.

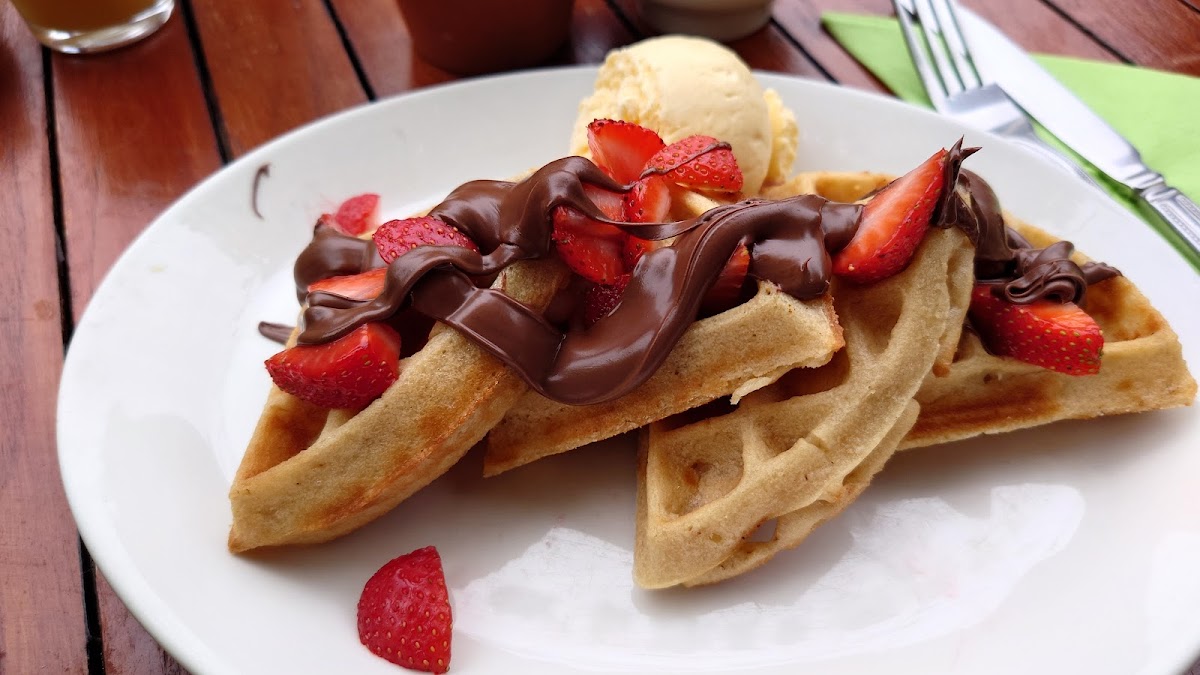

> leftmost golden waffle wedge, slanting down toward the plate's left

[{"left": 229, "top": 261, "right": 566, "bottom": 552}]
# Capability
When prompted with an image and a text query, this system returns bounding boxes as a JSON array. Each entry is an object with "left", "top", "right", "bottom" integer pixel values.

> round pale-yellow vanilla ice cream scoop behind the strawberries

[{"left": 571, "top": 35, "right": 798, "bottom": 195}]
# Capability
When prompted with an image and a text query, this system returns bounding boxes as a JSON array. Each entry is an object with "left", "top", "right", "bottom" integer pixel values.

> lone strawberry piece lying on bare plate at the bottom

[{"left": 359, "top": 546, "right": 452, "bottom": 673}]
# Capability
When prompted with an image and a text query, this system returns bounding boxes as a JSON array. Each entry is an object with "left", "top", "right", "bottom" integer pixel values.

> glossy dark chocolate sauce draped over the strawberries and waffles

[{"left": 285, "top": 141, "right": 1120, "bottom": 405}]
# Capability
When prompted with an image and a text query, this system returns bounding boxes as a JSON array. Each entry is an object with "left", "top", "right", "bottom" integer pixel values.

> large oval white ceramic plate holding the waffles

[{"left": 59, "top": 68, "right": 1200, "bottom": 675}]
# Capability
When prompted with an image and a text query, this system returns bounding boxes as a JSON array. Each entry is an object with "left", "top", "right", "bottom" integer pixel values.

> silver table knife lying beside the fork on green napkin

[{"left": 959, "top": 5, "right": 1200, "bottom": 265}]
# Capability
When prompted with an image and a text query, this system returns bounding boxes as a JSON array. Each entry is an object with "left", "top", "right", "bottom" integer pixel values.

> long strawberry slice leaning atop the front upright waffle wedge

[{"left": 833, "top": 150, "right": 946, "bottom": 283}]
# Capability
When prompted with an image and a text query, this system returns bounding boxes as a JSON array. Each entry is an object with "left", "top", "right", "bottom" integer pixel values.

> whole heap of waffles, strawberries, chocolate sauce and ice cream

[{"left": 229, "top": 37, "right": 1195, "bottom": 587}]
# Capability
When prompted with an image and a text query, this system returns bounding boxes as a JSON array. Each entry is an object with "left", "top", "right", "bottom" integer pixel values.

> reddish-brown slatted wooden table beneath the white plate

[{"left": 0, "top": 0, "right": 1200, "bottom": 675}]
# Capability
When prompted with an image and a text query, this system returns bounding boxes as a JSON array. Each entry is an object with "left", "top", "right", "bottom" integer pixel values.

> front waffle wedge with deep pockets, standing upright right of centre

[{"left": 634, "top": 224, "right": 972, "bottom": 589}]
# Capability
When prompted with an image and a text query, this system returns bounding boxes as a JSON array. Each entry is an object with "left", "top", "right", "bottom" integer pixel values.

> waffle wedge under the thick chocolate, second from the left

[{"left": 484, "top": 189, "right": 844, "bottom": 476}]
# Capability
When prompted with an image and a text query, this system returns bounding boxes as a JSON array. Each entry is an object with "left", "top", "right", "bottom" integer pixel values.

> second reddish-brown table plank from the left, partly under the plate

[{"left": 53, "top": 7, "right": 221, "bottom": 675}]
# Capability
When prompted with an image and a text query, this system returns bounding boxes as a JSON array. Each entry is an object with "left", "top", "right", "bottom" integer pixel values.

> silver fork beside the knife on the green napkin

[{"left": 892, "top": 0, "right": 1099, "bottom": 187}]
